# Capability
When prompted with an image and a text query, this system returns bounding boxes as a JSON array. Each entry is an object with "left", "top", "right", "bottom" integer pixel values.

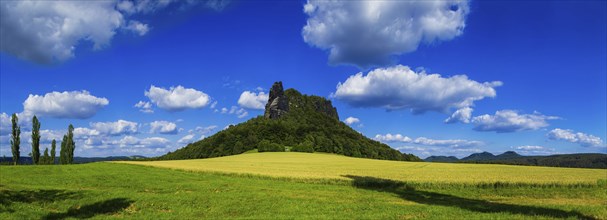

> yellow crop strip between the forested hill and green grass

[{"left": 119, "top": 152, "right": 607, "bottom": 185}]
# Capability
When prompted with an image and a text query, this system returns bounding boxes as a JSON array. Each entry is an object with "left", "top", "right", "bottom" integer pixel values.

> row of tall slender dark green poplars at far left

[{"left": 10, "top": 114, "right": 76, "bottom": 165}]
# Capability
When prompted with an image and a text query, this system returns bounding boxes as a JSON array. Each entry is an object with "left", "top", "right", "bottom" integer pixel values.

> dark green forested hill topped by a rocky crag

[{"left": 155, "top": 82, "right": 421, "bottom": 161}]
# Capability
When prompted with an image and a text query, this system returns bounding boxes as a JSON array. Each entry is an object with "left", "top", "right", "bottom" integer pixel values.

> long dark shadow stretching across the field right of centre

[{"left": 344, "top": 175, "right": 594, "bottom": 219}]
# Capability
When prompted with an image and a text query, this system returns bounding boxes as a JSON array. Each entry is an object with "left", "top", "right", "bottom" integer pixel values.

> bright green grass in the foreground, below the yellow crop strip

[{"left": 0, "top": 153, "right": 607, "bottom": 219}]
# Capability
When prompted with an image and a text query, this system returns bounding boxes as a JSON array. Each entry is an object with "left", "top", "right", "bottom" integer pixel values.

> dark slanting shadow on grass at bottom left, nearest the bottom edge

[{"left": 42, "top": 198, "right": 133, "bottom": 219}]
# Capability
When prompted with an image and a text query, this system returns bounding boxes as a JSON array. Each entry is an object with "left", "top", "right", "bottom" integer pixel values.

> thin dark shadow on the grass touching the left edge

[{"left": 0, "top": 190, "right": 80, "bottom": 212}]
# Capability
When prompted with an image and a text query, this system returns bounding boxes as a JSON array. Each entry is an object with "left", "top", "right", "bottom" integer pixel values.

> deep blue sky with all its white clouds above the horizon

[{"left": 0, "top": 1, "right": 607, "bottom": 158}]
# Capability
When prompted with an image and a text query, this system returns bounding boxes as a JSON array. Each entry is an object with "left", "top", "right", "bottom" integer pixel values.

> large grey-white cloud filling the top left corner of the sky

[{"left": 0, "top": 0, "right": 227, "bottom": 63}]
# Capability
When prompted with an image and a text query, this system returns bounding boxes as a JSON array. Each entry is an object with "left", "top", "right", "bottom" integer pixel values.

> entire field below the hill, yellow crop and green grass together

[{"left": 0, "top": 153, "right": 607, "bottom": 219}]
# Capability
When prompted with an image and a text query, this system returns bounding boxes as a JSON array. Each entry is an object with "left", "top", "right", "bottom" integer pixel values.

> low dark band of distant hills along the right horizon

[{"left": 424, "top": 151, "right": 607, "bottom": 169}]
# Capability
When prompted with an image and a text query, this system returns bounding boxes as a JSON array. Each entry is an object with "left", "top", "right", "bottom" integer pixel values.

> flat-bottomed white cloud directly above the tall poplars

[{"left": 23, "top": 90, "right": 110, "bottom": 119}]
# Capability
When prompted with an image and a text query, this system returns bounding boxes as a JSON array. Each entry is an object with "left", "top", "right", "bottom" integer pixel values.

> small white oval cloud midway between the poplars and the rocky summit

[{"left": 145, "top": 85, "right": 211, "bottom": 112}]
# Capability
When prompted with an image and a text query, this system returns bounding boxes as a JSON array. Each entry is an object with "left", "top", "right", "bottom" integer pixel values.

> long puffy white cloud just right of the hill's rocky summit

[{"left": 332, "top": 65, "right": 502, "bottom": 113}]
